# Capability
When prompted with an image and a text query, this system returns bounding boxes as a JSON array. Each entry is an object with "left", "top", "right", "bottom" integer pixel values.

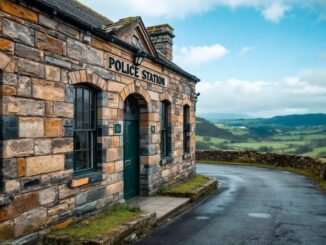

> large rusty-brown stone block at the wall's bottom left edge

[{"left": 0, "top": 192, "right": 38, "bottom": 222}]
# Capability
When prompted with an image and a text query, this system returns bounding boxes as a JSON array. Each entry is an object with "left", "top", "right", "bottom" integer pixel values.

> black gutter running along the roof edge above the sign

[{"left": 24, "top": 0, "right": 200, "bottom": 83}]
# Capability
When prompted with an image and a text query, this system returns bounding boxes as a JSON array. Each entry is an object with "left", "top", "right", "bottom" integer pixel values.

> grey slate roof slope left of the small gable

[{"left": 37, "top": 0, "right": 113, "bottom": 27}]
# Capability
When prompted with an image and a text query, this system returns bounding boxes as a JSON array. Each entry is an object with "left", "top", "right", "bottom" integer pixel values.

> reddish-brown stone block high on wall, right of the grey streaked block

[{"left": 35, "top": 32, "right": 65, "bottom": 55}]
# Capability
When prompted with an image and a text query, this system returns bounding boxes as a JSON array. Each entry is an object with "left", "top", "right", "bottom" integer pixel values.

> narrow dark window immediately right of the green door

[{"left": 161, "top": 101, "right": 171, "bottom": 157}]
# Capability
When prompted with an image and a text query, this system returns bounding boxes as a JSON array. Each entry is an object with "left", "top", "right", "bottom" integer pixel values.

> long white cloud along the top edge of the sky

[{"left": 81, "top": 0, "right": 326, "bottom": 22}]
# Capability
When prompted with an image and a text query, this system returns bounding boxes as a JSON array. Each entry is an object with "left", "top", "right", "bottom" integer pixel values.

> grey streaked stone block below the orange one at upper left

[{"left": 2, "top": 19, "right": 34, "bottom": 46}]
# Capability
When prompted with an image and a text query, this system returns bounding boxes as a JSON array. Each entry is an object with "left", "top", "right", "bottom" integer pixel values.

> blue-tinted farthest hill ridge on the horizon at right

[{"left": 223, "top": 113, "right": 326, "bottom": 127}]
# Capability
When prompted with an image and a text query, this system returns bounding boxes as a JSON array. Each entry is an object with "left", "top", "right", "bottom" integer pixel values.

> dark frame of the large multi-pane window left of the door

[{"left": 73, "top": 84, "right": 97, "bottom": 176}]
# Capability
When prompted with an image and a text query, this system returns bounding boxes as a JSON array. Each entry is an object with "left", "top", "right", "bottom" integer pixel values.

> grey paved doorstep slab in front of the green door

[{"left": 128, "top": 196, "right": 190, "bottom": 221}]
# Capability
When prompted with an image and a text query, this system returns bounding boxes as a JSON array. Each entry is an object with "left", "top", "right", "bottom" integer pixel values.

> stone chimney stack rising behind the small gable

[{"left": 147, "top": 24, "right": 175, "bottom": 61}]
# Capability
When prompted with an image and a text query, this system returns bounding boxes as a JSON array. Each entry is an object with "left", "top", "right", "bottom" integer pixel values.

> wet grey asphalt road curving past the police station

[{"left": 137, "top": 164, "right": 326, "bottom": 245}]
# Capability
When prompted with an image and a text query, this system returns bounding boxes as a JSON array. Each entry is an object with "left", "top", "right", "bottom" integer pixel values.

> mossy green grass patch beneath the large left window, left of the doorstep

[{"left": 60, "top": 204, "right": 141, "bottom": 239}]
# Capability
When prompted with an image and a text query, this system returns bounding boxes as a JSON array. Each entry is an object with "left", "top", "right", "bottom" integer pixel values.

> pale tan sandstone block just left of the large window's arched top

[{"left": 32, "top": 79, "right": 65, "bottom": 101}]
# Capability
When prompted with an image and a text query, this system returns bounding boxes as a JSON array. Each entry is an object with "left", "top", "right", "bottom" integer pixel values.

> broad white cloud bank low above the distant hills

[{"left": 197, "top": 69, "right": 326, "bottom": 117}]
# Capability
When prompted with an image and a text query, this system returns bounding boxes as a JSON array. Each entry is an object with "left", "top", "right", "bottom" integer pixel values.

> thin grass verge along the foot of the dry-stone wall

[{"left": 197, "top": 160, "right": 326, "bottom": 192}]
